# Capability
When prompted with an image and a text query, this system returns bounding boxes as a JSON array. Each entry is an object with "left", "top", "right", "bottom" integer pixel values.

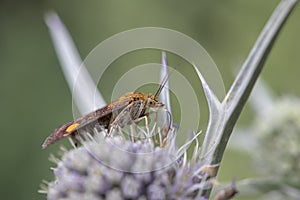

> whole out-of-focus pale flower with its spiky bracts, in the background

[{"left": 233, "top": 84, "right": 300, "bottom": 200}]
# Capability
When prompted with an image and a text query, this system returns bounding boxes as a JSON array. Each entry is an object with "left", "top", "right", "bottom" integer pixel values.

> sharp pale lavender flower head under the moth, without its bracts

[{"left": 41, "top": 132, "right": 212, "bottom": 200}]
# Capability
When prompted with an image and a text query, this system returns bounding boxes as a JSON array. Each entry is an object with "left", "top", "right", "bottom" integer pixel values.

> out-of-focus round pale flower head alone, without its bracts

[{"left": 254, "top": 97, "right": 300, "bottom": 187}]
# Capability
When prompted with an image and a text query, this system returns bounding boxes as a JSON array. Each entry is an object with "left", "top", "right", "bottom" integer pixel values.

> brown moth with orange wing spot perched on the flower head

[{"left": 42, "top": 77, "right": 170, "bottom": 148}]
